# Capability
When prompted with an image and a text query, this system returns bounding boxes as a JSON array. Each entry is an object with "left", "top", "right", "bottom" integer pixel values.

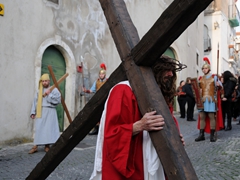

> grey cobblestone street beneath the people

[{"left": 0, "top": 114, "right": 240, "bottom": 180}]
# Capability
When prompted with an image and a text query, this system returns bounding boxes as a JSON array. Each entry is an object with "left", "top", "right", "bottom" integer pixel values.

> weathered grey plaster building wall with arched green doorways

[{"left": 0, "top": 0, "right": 219, "bottom": 144}]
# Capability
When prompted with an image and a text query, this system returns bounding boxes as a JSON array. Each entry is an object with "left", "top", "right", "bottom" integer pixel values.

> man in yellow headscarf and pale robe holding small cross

[{"left": 29, "top": 74, "right": 61, "bottom": 154}]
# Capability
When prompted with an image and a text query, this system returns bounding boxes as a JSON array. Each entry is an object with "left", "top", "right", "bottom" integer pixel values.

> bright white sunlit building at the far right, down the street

[{"left": 204, "top": 0, "right": 240, "bottom": 75}]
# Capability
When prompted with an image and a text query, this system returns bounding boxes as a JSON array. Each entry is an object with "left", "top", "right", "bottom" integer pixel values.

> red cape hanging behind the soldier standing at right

[{"left": 197, "top": 90, "right": 224, "bottom": 133}]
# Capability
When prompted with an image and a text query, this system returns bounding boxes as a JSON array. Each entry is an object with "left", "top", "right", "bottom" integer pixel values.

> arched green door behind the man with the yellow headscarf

[{"left": 41, "top": 46, "right": 66, "bottom": 132}]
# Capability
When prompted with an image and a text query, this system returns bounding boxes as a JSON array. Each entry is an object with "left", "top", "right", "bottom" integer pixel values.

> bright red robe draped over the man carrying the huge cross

[{"left": 102, "top": 84, "right": 177, "bottom": 180}]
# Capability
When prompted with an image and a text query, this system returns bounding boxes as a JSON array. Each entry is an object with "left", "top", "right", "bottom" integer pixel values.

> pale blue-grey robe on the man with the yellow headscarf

[{"left": 31, "top": 88, "right": 61, "bottom": 145}]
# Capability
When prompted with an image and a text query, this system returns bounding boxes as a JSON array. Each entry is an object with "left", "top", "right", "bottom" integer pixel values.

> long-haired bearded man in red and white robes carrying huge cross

[{"left": 90, "top": 55, "right": 186, "bottom": 180}]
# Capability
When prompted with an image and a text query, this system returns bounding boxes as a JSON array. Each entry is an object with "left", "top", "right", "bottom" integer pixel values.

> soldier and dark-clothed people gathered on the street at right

[{"left": 176, "top": 57, "right": 240, "bottom": 142}]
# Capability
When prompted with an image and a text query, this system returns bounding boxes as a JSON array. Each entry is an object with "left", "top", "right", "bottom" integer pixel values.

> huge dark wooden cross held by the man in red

[{"left": 27, "top": 0, "right": 212, "bottom": 180}]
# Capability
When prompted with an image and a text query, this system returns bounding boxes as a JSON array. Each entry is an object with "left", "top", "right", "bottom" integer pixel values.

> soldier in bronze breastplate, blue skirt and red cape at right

[{"left": 195, "top": 57, "right": 223, "bottom": 142}]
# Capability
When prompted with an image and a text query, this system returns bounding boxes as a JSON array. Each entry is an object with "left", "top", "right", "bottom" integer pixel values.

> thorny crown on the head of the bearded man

[{"left": 157, "top": 55, "right": 187, "bottom": 72}]
